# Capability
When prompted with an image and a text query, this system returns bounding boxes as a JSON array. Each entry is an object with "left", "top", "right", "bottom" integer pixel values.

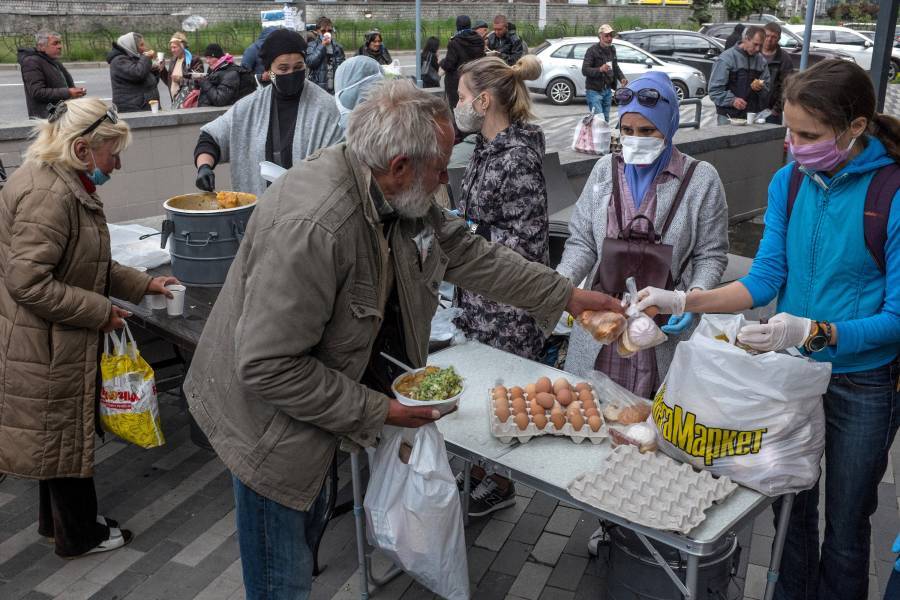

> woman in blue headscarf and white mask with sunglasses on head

[{"left": 557, "top": 71, "right": 728, "bottom": 398}]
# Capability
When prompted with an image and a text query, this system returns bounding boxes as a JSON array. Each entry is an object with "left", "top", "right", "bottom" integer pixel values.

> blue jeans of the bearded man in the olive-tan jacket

[{"left": 231, "top": 475, "right": 326, "bottom": 600}]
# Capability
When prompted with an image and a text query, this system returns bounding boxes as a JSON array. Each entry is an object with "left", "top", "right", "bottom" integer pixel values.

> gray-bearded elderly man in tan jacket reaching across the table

[{"left": 184, "top": 80, "right": 621, "bottom": 599}]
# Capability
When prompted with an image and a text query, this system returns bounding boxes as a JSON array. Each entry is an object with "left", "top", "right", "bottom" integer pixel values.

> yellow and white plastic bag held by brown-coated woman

[{"left": 100, "top": 323, "right": 166, "bottom": 448}]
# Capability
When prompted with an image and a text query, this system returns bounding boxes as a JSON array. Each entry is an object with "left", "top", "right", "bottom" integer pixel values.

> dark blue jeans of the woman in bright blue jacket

[{"left": 775, "top": 361, "right": 900, "bottom": 600}]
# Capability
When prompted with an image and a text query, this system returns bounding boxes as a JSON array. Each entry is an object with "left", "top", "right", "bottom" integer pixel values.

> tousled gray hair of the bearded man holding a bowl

[{"left": 347, "top": 79, "right": 452, "bottom": 172}]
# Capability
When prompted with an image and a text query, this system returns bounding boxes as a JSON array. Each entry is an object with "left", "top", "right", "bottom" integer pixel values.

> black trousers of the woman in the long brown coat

[{"left": 38, "top": 477, "right": 109, "bottom": 557}]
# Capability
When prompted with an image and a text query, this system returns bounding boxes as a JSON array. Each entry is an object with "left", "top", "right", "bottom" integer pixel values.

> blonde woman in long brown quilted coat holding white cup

[{"left": 0, "top": 98, "right": 177, "bottom": 558}]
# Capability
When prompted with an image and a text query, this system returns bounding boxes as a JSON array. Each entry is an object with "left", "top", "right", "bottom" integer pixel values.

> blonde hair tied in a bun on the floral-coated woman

[{"left": 459, "top": 54, "right": 541, "bottom": 122}]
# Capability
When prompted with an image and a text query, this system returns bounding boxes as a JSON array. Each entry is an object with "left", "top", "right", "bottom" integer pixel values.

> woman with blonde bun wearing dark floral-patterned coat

[{"left": 453, "top": 55, "right": 550, "bottom": 517}]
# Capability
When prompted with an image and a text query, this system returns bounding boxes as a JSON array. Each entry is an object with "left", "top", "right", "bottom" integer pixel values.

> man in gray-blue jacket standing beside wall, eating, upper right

[{"left": 709, "top": 25, "right": 771, "bottom": 125}]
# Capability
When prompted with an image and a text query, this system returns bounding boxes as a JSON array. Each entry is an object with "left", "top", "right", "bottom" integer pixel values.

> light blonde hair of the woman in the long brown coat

[{"left": 25, "top": 98, "right": 131, "bottom": 170}]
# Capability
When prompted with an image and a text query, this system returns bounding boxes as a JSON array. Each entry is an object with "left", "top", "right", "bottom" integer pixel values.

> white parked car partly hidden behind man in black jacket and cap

[{"left": 527, "top": 37, "right": 706, "bottom": 104}]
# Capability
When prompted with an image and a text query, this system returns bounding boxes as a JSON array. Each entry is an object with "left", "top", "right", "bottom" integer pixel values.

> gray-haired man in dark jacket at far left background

[{"left": 17, "top": 31, "right": 87, "bottom": 119}]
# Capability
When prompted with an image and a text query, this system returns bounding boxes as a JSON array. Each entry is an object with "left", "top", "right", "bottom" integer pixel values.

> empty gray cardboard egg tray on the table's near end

[{"left": 568, "top": 446, "right": 737, "bottom": 534}]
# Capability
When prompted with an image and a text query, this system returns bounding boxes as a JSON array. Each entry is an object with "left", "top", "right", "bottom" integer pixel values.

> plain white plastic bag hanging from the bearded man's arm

[{"left": 363, "top": 423, "right": 469, "bottom": 600}]
